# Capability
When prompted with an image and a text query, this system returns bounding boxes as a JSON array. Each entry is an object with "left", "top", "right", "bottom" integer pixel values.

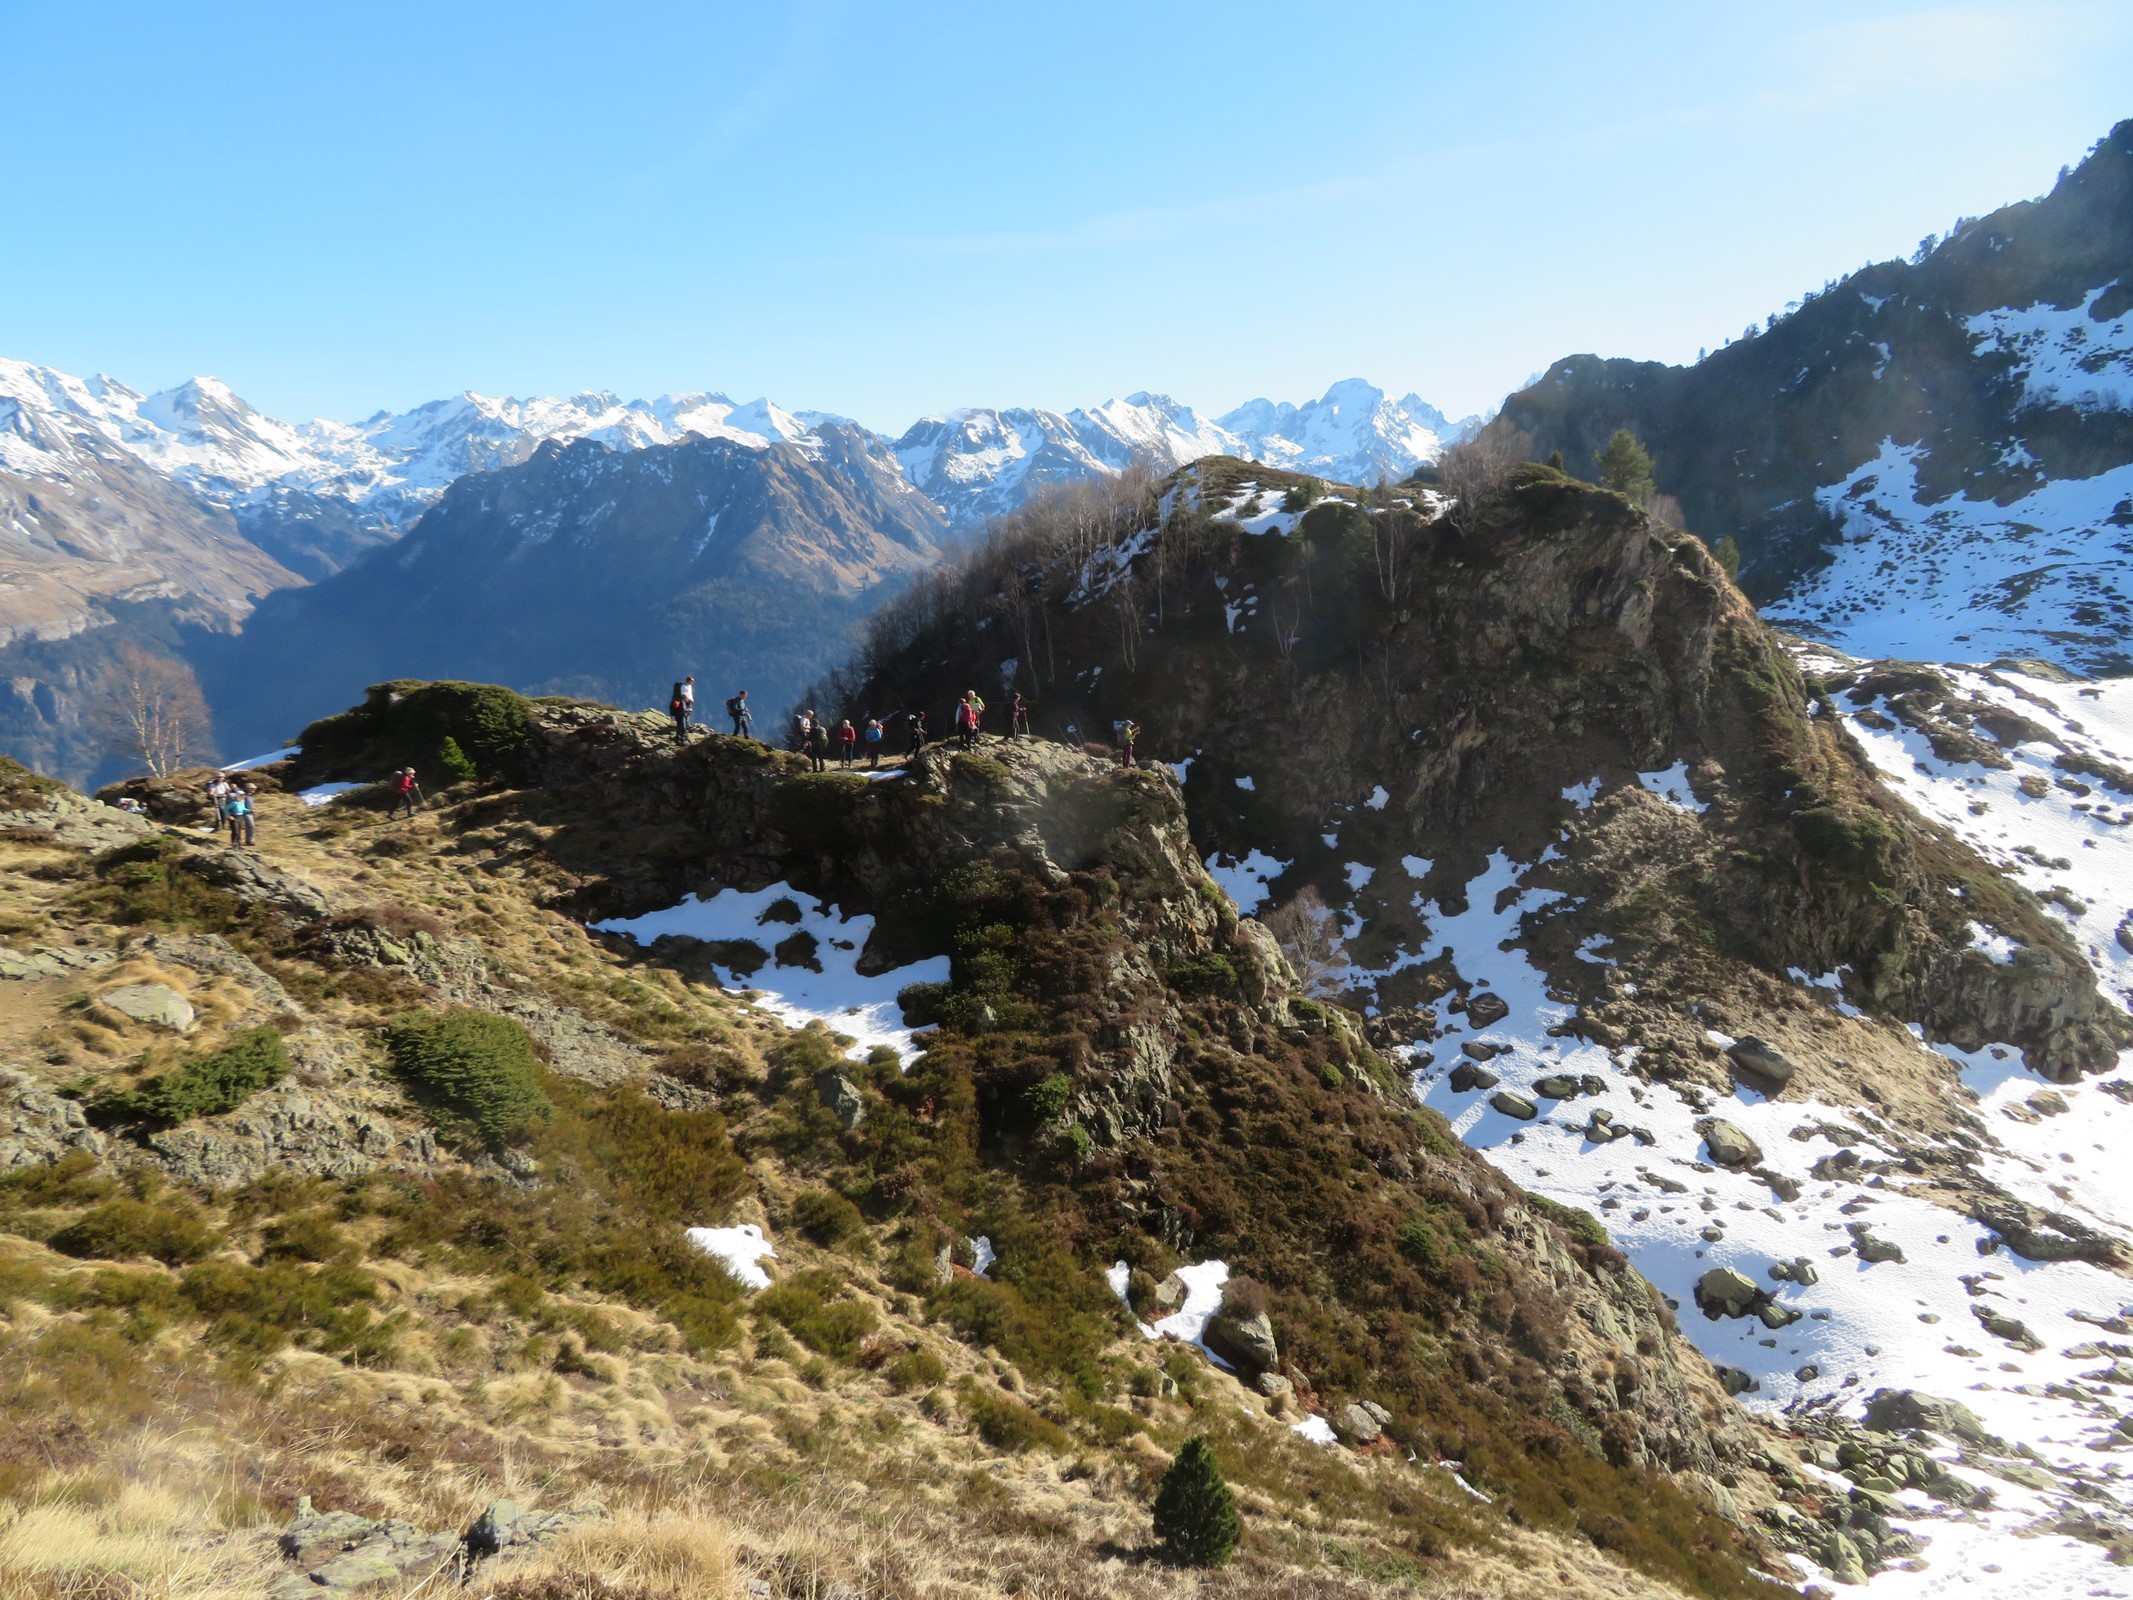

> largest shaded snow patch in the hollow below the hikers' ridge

[{"left": 593, "top": 883, "right": 949, "bottom": 1065}]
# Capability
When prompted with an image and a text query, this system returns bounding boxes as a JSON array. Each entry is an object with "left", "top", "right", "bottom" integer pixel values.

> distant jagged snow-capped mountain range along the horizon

[{"left": 0, "top": 358, "right": 1480, "bottom": 529}]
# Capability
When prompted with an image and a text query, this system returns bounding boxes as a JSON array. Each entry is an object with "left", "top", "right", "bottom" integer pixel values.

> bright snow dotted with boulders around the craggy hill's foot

[{"left": 1390, "top": 646, "right": 2133, "bottom": 1596}]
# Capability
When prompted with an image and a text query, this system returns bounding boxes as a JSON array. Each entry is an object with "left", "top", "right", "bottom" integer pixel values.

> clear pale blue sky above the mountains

[{"left": 0, "top": 0, "right": 2133, "bottom": 431}]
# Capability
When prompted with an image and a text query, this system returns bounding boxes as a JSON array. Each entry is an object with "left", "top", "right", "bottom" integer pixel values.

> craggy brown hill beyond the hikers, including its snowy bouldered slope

[{"left": 819, "top": 461, "right": 2133, "bottom": 1587}]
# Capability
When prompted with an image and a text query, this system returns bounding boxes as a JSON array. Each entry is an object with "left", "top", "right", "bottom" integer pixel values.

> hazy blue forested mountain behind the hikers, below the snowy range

[{"left": 196, "top": 427, "right": 947, "bottom": 763}]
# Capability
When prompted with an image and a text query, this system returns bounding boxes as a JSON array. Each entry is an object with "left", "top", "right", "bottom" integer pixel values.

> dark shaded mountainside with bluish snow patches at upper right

[{"left": 1502, "top": 122, "right": 2133, "bottom": 672}]
